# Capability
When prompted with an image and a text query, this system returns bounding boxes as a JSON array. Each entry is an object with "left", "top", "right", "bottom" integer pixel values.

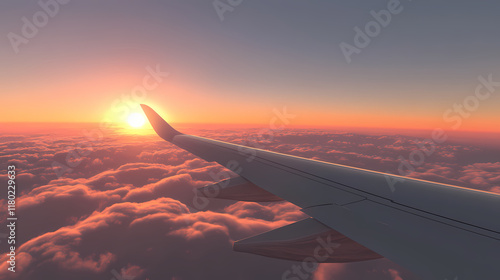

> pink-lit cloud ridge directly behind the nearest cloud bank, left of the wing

[{"left": 11, "top": 160, "right": 228, "bottom": 245}]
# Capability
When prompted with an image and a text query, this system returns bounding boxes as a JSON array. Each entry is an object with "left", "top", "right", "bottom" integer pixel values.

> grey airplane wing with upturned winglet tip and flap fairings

[{"left": 141, "top": 105, "right": 500, "bottom": 280}]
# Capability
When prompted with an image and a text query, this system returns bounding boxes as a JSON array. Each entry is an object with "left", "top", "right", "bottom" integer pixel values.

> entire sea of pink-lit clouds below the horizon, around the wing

[{"left": 0, "top": 126, "right": 500, "bottom": 280}]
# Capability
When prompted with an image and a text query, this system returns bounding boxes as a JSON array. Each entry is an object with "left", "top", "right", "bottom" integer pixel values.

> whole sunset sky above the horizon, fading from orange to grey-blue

[{"left": 0, "top": 0, "right": 500, "bottom": 132}]
